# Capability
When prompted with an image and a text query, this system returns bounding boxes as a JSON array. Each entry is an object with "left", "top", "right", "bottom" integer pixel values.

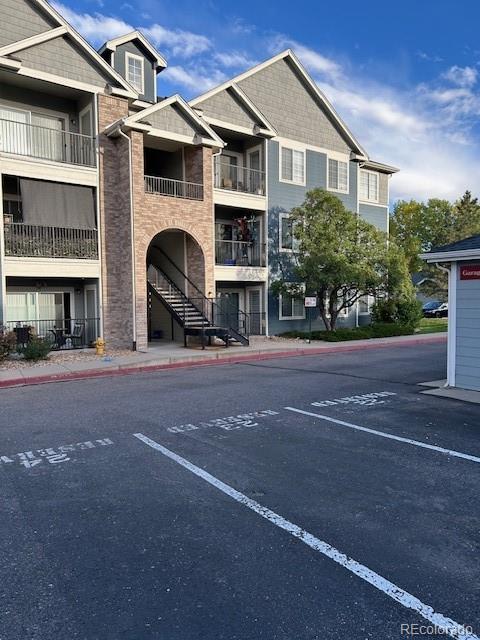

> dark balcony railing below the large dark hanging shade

[{"left": 4, "top": 223, "right": 98, "bottom": 260}]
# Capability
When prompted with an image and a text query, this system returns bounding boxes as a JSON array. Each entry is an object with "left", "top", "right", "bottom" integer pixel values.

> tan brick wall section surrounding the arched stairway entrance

[{"left": 130, "top": 131, "right": 215, "bottom": 349}]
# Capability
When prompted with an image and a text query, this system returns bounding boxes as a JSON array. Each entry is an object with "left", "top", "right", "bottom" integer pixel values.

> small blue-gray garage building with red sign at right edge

[{"left": 422, "top": 235, "right": 480, "bottom": 391}]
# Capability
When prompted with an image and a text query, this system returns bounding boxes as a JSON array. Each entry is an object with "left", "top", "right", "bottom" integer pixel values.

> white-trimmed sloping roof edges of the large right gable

[{"left": 190, "top": 49, "right": 368, "bottom": 160}]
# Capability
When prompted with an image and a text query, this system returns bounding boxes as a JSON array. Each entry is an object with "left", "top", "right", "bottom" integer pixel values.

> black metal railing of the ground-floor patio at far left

[{"left": 4, "top": 318, "right": 100, "bottom": 351}]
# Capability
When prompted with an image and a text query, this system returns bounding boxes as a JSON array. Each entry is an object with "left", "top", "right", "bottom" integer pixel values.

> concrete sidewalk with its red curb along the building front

[{"left": 0, "top": 333, "right": 447, "bottom": 388}]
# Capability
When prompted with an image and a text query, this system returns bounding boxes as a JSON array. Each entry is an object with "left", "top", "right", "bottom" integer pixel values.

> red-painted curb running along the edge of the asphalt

[{"left": 0, "top": 336, "right": 446, "bottom": 389}]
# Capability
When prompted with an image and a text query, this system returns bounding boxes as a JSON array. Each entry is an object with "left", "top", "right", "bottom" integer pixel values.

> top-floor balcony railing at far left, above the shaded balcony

[{"left": 0, "top": 118, "right": 96, "bottom": 167}]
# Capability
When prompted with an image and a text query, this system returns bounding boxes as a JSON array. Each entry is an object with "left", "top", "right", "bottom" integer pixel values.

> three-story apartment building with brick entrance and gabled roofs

[{"left": 0, "top": 0, "right": 395, "bottom": 349}]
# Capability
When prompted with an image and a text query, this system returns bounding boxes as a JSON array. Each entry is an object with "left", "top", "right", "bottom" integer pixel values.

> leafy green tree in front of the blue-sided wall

[{"left": 272, "top": 189, "right": 414, "bottom": 331}]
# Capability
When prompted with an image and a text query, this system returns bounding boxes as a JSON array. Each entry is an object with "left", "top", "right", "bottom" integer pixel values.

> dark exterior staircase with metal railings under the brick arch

[{"left": 147, "top": 262, "right": 249, "bottom": 348}]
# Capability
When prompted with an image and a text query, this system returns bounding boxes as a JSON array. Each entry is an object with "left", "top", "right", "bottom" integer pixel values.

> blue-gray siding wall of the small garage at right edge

[{"left": 455, "top": 261, "right": 480, "bottom": 391}]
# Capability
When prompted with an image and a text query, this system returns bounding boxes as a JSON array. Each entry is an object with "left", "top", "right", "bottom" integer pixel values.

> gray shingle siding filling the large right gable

[{"left": 238, "top": 59, "right": 350, "bottom": 153}]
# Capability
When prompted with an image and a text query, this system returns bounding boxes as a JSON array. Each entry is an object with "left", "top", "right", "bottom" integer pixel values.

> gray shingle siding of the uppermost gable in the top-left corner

[{"left": 0, "top": 0, "right": 58, "bottom": 47}]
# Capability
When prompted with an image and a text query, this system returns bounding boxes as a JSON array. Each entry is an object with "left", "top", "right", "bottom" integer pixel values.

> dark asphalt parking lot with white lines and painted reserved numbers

[{"left": 0, "top": 345, "right": 480, "bottom": 640}]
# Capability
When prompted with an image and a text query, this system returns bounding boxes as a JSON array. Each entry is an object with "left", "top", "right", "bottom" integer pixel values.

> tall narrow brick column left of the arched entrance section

[{"left": 98, "top": 95, "right": 133, "bottom": 348}]
